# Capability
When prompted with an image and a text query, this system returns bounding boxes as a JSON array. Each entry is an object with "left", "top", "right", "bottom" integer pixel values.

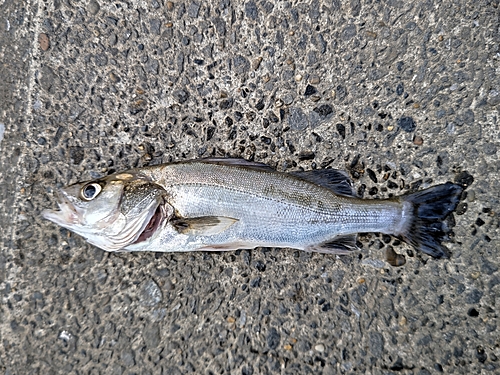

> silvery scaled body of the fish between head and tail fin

[{"left": 137, "top": 163, "right": 402, "bottom": 248}]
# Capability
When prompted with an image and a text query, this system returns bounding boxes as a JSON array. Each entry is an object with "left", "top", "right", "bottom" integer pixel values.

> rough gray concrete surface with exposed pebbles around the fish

[{"left": 0, "top": 0, "right": 500, "bottom": 375}]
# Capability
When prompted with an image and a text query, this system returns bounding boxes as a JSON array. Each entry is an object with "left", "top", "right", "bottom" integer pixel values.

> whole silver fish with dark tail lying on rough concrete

[{"left": 42, "top": 158, "right": 464, "bottom": 258}]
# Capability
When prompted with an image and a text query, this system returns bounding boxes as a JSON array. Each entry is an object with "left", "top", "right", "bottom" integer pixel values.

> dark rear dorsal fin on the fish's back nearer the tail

[{"left": 291, "top": 169, "right": 356, "bottom": 197}]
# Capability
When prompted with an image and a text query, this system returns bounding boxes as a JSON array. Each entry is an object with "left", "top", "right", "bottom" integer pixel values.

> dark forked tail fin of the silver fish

[{"left": 400, "top": 182, "right": 463, "bottom": 258}]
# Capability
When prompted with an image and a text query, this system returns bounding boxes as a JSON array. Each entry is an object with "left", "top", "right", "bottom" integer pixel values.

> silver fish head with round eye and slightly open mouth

[{"left": 42, "top": 173, "right": 173, "bottom": 251}]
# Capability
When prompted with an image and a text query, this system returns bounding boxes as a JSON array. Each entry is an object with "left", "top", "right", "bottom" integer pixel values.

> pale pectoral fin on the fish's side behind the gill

[{"left": 171, "top": 216, "right": 238, "bottom": 236}]
